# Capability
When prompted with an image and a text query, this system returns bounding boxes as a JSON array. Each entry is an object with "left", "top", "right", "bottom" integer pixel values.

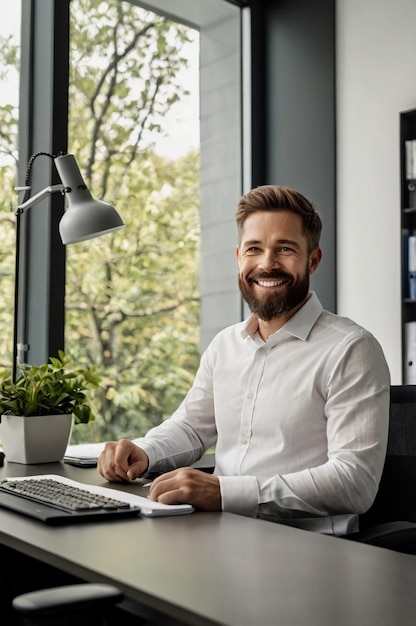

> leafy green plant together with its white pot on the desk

[{"left": 0, "top": 351, "right": 99, "bottom": 463}]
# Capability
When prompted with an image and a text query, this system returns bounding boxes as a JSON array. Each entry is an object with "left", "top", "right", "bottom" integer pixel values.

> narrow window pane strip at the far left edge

[{"left": 0, "top": 0, "right": 20, "bottom": 373}]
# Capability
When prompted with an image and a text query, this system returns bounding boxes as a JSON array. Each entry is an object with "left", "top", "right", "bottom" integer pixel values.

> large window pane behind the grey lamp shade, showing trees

[{"left": 65, "top": 0, "right": 200, "bottom": 443}]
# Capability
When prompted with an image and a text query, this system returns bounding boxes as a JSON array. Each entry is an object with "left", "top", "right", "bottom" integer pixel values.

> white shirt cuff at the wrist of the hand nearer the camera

[{"left": 218, "top": 476, "right": 259, "bottom": 517}]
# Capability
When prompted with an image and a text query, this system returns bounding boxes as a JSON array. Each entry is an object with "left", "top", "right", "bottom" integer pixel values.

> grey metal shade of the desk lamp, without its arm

[{"left": 55, "top": 154, "right": 124, "bottom": 244}]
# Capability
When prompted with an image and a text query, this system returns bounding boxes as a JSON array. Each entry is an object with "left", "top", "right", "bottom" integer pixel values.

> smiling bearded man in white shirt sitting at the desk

[{"left": 98, "top": 185, "right": 390, "bottom": 534}]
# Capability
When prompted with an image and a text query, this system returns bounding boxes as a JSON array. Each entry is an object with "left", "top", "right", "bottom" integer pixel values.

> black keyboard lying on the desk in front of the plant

[{"left": 0, "top": 477, "right": 140, "bottom": 525}]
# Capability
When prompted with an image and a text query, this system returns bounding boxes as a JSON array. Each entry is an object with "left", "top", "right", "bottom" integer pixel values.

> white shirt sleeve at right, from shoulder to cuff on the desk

[{"left": 220, "top": 334, "right": 390, "bottom": 520}]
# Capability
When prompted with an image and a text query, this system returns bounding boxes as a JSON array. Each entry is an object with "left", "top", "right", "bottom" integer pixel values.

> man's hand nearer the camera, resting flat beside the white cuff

[{"left": 149, "top": 467, "right": 221, "bottom": 511}]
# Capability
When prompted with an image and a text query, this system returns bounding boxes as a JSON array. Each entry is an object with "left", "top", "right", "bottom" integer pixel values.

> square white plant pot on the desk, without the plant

[{"left": 0, "top": 415, "right": 73, "bottom": 464}]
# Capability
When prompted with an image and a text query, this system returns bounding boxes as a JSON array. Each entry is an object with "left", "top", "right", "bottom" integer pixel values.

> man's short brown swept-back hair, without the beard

[{"left": 236, "top": 185, "right": 322, "bottom": 252}]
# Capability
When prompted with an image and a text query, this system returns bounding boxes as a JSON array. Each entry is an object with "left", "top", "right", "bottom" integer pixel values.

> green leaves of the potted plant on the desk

[{"left": 0, "top": 352, "right": 99, "bottom": 423}]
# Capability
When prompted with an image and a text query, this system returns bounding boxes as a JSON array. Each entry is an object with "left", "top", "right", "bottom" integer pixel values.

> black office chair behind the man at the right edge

[{"left": 346, "top": 385, "right": 416, "bottom": 554}]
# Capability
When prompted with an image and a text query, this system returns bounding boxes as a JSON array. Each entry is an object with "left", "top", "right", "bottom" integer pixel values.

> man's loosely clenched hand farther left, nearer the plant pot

[{"left": 97, "top": 439, "right": 149, "bottom": 482}]
